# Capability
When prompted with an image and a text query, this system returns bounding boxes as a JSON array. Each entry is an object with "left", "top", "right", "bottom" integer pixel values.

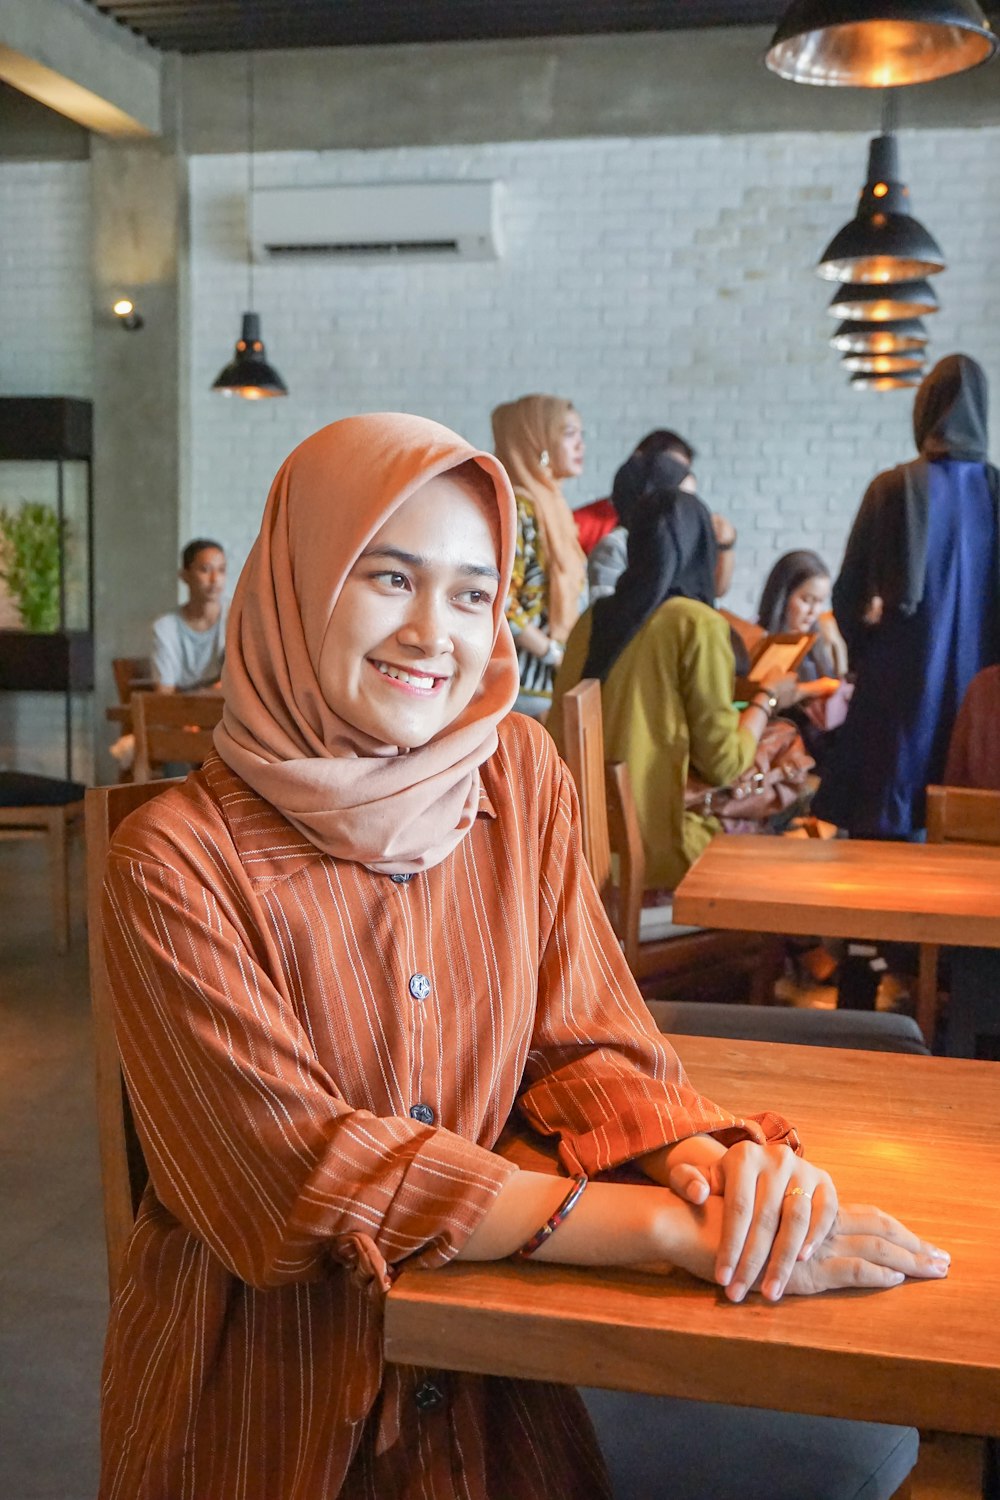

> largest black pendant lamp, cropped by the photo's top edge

[{"left": 765, "top": 0, "right": 999, "bottom": 89}]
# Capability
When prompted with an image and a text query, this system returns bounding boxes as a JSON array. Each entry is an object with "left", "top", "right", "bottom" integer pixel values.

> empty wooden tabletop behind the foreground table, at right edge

[{"left": 673, "top": 834, "right": 1000, "bottom": 948}]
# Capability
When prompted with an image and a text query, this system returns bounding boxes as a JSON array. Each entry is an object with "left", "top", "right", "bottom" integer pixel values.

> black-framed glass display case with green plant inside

[{"left": 0, "top": 396, "right": 94, "bottom": 765}]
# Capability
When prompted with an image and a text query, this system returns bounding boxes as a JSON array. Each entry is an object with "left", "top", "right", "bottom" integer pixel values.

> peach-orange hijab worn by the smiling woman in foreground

[{"left": 214, "top": 413, "right": 517, "bottom": 875}]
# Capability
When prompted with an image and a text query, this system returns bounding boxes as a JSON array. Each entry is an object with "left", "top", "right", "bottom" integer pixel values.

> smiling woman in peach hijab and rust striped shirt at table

[{"left": 100, "top": 414, "right": 946, "bottom": 1500}]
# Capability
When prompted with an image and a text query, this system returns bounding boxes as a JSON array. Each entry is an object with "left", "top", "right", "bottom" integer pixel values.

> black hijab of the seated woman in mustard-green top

[{"left": 582, "top": 455, "right": 715, "bottom": 683}]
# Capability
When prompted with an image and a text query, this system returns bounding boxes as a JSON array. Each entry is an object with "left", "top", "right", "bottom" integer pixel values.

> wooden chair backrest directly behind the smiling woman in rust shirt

[{"left": 85, "top": 782, "right": 175, "bottom": 1298}]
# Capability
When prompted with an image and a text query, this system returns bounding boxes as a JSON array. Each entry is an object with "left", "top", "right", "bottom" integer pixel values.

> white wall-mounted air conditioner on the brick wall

[{"left": 253, "top": 182, "right": 502, "bottom": 261}]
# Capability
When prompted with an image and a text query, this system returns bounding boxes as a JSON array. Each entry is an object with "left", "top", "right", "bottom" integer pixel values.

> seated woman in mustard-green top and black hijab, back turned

[{"left": 552, "top": 459, "right": 796, "bottom": 891}]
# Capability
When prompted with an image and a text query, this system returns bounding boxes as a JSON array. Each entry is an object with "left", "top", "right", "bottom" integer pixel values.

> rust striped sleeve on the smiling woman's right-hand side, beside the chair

[{"left": 519, "top": 747, "right": 798, "bottom": 1175}]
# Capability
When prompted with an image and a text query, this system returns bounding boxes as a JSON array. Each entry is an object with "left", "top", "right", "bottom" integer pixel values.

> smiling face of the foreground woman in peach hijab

[{"left": 319, "top": 474, "right": 499, "bottom": 750}]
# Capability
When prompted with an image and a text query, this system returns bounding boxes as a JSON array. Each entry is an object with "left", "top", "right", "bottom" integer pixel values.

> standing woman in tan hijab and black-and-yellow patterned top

[{"left": 493, "top": 396, "right": 586, "bottom": 719}]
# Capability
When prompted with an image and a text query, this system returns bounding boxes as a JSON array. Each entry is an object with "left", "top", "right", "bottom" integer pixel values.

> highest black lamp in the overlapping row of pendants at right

[{"left": 816, "top": 135, "right": 945, "bottom": 282}]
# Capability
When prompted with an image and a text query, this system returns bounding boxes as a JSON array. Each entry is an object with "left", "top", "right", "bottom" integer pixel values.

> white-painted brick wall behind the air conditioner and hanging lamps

[{"left": 187, "top": 129, "right": 1000, "bottom": 611}]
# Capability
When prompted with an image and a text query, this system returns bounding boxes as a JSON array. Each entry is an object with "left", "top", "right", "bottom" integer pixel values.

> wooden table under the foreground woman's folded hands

[{"left": 385, "top": 1037, "right": 1000, "bottom": 1436}]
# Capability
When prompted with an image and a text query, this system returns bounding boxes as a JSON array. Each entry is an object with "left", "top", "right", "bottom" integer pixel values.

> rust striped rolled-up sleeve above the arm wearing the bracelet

[{"left": 103, "top": 839, "right": 517, "bottom": 1287}]
